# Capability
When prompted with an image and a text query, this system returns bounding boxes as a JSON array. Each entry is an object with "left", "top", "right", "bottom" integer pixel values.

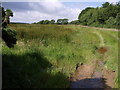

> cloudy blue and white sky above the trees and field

[{"left": 2, "top": 0, "right": 119, "bottom": 23}]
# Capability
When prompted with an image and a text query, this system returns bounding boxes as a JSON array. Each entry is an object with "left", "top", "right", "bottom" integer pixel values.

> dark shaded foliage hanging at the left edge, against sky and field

[{"left": 0, "top": 7, "right": 17, "bottom": 47}]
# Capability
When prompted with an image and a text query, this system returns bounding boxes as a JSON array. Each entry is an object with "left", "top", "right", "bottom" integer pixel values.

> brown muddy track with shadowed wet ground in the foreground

[{"left": 71, "top": 60, "right": 115, "bottom": 90}]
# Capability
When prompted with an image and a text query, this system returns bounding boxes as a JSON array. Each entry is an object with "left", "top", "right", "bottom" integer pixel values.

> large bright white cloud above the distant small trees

[{"left": 11, "top": 0, "right": 81, "bottom": 23}]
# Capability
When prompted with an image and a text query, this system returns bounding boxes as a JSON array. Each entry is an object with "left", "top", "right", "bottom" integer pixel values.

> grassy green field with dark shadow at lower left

[{"left": 2, "top": 24, "right": 120, "bottom": 88}]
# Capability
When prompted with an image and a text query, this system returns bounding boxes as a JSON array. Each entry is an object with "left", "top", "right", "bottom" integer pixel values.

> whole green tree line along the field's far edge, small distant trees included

[{"left": 34, "top": 2, "right": 120, "bottom": 28}]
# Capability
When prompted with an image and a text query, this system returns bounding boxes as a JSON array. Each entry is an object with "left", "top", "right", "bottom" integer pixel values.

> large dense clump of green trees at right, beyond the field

[{"left": 78, "top": 2, "right": 120, "bottom": 28}]
